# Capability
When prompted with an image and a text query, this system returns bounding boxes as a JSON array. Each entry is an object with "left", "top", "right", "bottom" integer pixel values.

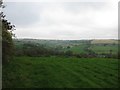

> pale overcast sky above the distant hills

[{"left": 3, "top": 0, "right": 118, "bottom": 40}]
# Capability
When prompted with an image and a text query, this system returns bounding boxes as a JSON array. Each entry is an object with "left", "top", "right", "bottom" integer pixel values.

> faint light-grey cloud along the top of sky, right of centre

[{"left": 63, "top": 2, "right": 107, "bottom": 13}]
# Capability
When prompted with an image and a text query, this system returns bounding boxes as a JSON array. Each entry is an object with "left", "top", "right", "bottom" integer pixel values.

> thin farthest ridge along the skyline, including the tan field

[{"left": 14, "top": 39, "right": 120, "bottom": 46}]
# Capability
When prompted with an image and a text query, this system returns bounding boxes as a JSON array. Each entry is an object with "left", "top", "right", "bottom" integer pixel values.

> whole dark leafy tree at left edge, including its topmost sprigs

[{"left": 0, "top": 0, "right": 15, "bottom": 64}]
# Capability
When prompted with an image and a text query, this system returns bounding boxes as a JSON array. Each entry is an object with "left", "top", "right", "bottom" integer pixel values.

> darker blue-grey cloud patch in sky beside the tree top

[{"left": 4, "top": 2, "right": 40, "bottom": 27}]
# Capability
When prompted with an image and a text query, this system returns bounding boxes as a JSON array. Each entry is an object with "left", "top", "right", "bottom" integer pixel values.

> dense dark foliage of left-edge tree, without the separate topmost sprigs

[{"left": 2, "top": 19, "right": 13, "bottom": 64}]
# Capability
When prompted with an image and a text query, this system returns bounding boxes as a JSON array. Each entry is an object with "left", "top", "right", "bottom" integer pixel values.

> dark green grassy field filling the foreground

[{"left": 3, "top": 56, "right": 118, "bottom": 88}]
